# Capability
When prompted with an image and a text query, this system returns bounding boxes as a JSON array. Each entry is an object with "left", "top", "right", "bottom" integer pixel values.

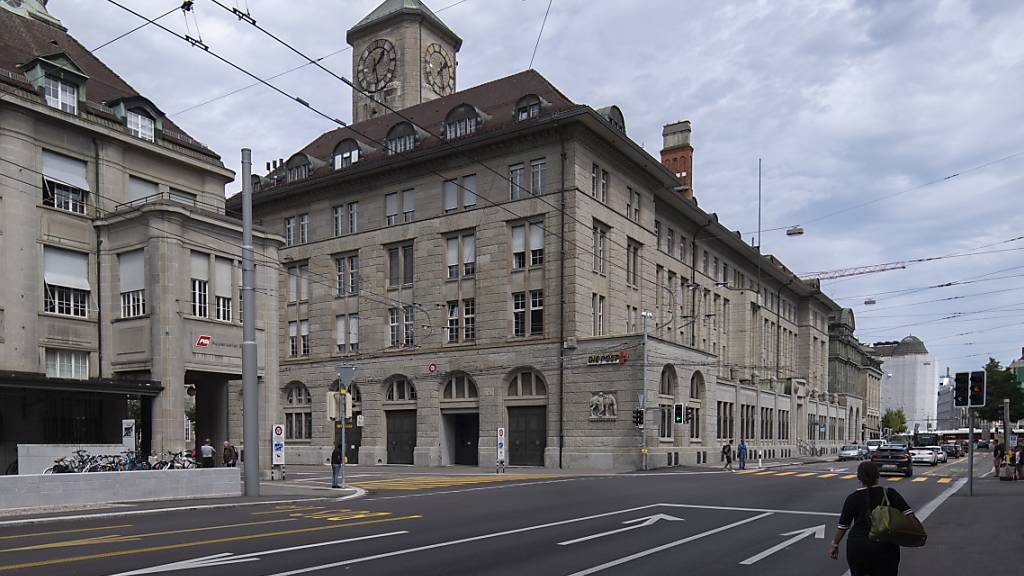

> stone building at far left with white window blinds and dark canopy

[{"left": 0, "top": 0, "right": 281, "bottom": 467}]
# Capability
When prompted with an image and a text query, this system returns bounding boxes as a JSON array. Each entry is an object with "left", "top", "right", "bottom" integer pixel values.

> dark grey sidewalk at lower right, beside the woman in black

[{"left": 900, "top": 477, "right": 1024, "bottom": 576}]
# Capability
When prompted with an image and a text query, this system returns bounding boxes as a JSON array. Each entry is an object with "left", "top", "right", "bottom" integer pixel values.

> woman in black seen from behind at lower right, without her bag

[{"left": 828, "top": 461, "right": 913, "bottom": 576}]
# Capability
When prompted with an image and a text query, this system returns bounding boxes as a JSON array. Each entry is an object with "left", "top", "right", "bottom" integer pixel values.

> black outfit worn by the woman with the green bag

[{"left": 839, "top": 486, "right": 913, "bottom": 576}]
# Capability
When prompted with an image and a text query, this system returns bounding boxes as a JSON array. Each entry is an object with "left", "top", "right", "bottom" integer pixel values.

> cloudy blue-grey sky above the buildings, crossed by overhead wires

[{"left": 49, "top": 0, "right": 1024, "bottom": 371}]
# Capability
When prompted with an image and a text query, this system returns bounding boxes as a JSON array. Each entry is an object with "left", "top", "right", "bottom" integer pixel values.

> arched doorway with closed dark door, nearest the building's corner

[{"left": 505, "top": 368, "right": 548, "bottom": 466}]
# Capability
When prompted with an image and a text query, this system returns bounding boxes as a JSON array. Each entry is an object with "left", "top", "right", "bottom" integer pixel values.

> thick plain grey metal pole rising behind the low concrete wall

[{"left": 242, "top": 148, "right": 260, "bottom": 496}]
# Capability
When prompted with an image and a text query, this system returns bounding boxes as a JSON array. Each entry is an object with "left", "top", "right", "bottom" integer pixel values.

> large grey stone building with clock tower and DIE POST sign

[{"left": 235, "top": 0, "right": 847, "bottom": 469}]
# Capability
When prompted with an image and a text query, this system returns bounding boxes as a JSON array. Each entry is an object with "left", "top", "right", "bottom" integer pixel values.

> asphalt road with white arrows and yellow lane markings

[{"left": 0, "top": 461, "right": 978, "bottom": 576}]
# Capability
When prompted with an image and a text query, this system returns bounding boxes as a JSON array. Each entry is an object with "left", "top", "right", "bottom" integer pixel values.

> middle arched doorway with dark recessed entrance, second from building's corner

[{"left": 440, "top": 373, "right": 480, "bottom": 466}]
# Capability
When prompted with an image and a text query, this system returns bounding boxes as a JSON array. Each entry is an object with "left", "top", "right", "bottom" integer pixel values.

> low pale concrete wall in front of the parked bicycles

[{"left": 0, "top": 468, "right": 242, "bottom": 509}]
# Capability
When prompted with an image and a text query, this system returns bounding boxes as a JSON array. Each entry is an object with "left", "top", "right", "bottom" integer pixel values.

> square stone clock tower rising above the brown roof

[{"left": 345, "top": 0, "right": 462, "bottom": 123}]
